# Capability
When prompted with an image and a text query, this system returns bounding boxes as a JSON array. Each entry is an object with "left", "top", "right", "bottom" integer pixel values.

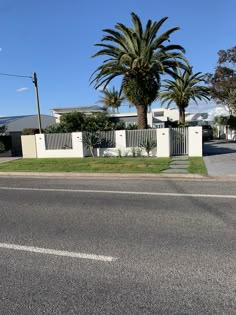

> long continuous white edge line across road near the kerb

[{"left": 0, "top": 187, "right": 236, "bottom": 199}]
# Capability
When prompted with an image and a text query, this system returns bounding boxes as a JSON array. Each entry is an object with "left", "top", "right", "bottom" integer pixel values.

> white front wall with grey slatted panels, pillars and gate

[{"left": 21, "top": 127, "right": 202, "bottom": 158}]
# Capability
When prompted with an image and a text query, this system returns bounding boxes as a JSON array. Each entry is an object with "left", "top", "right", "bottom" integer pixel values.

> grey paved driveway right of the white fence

[{"left": 203, "top": 140, "right": 236, "bottom": 175}]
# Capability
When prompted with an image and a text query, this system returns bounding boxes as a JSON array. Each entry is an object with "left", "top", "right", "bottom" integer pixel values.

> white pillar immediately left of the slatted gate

[{"left": 157, "top": 128, "right": 170, "bottom": 157}]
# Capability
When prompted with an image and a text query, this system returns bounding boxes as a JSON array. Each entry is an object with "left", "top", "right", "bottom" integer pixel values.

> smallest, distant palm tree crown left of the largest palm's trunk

[{"left": 99, "top": 87, "right": 125, "bottom": 113}]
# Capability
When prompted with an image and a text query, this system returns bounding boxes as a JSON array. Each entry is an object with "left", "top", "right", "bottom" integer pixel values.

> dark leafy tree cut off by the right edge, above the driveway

[{"left": 207, "top": 46, "right": 236, "bottom": 114}]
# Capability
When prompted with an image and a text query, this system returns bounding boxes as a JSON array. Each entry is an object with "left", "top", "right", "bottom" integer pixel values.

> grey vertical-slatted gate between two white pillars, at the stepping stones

[{"left": 170, "top": 128, "right": 188, "bottom": 156}]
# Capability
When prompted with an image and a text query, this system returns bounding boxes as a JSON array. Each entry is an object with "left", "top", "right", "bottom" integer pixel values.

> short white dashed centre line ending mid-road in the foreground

[{"left": 0, "top": 243, "right": 117, "bottom": 262}]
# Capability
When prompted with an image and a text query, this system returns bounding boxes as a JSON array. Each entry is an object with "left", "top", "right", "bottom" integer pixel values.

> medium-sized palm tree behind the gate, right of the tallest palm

[{"left": 158, "top": 67, "right": 210, "bottom": 124}]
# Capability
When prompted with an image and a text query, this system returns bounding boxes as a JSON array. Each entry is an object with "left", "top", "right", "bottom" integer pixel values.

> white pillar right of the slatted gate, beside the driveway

[{"left": 188, "top": 126, "right": 202, "bottom": 156}]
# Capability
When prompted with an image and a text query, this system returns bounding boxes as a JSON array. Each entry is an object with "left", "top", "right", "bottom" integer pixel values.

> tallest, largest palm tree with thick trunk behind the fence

[{"left": 90, "top": 13, "right": 185, "bottom": 129}]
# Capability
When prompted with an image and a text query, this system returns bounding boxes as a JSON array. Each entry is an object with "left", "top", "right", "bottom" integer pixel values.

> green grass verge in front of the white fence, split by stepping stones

[{"left": 0, "top": 157, "right": 207, "bottom": 174}]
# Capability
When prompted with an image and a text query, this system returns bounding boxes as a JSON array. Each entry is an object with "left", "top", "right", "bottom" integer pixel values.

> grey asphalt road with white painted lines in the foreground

[{"left": 0, "top": 177, "right": 236, "bottom": 315}]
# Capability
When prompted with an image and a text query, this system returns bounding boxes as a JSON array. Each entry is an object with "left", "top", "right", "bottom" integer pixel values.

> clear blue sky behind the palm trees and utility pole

[{"left": 0, "top": 0, "right": 236, "bottom": 116}]
